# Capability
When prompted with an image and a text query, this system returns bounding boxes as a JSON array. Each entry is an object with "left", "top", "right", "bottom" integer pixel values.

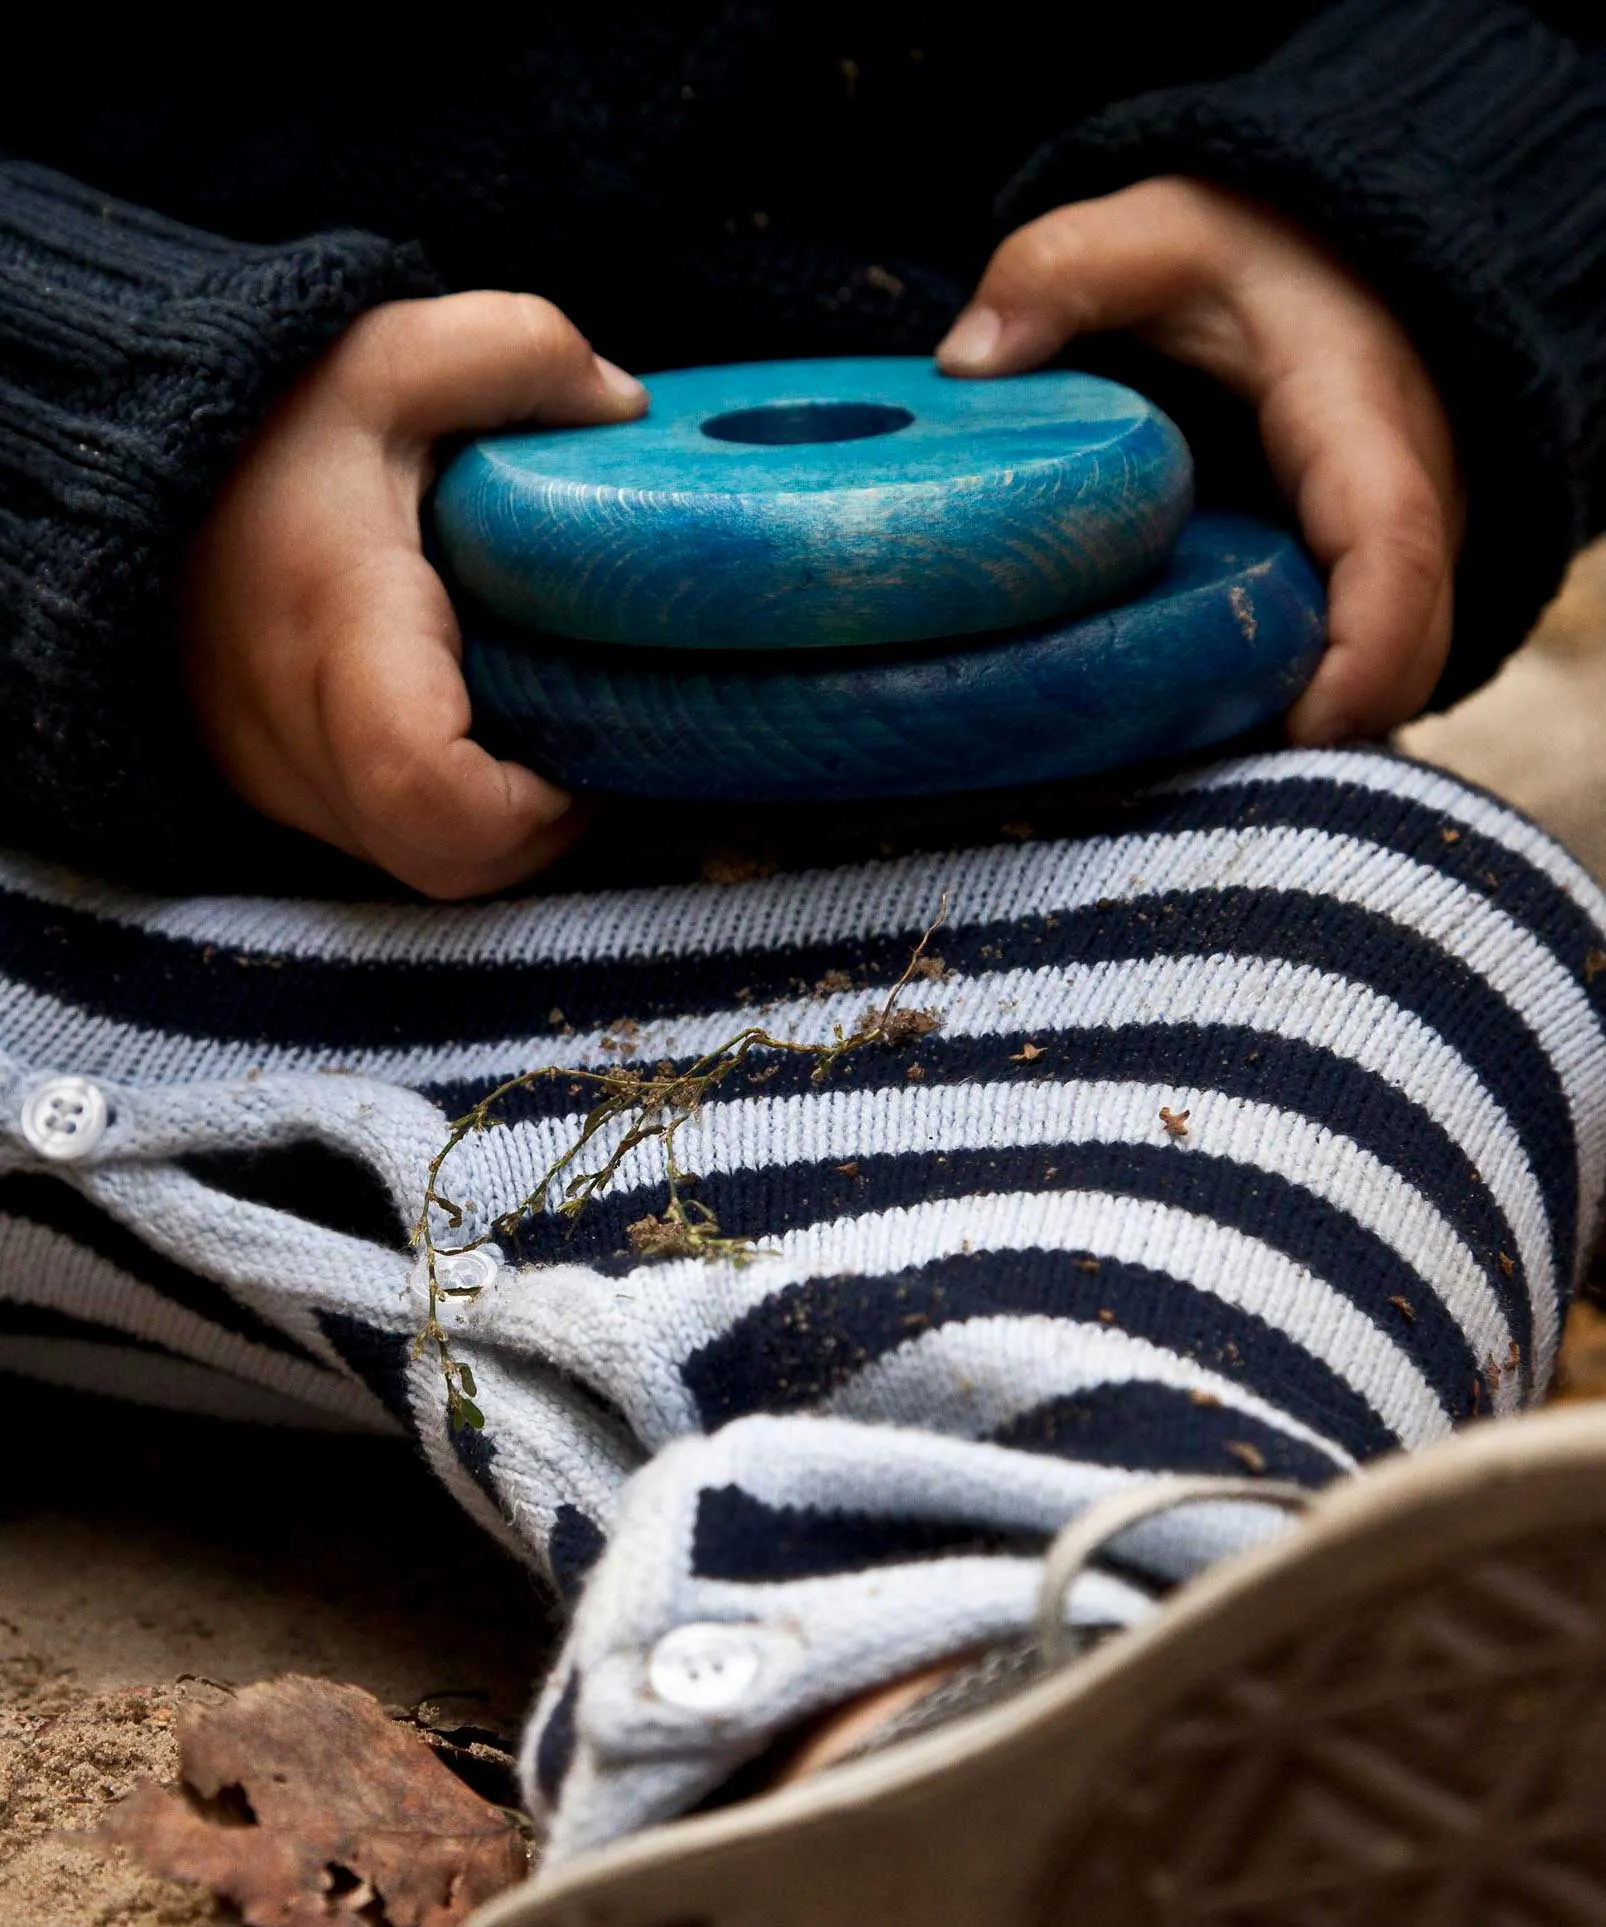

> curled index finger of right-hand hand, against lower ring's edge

[{"left": 1263, "top": 370, "right": 1456, "bottom": 744}]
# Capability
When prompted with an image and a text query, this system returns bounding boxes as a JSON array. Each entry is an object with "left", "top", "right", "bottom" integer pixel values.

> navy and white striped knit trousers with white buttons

[{"left": 0, "top": 752, "right": 1606, "bottom": 1858}]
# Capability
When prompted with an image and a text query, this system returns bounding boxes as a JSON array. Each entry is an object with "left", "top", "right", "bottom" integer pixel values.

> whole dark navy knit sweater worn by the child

[{"left": 0, "top": 0, "right": 1606, "bottom": 890}]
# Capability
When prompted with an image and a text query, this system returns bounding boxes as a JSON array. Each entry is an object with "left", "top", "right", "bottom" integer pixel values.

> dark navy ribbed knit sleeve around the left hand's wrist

[{"left": 0, "top": 162, "right": 438, "bottom": 877}]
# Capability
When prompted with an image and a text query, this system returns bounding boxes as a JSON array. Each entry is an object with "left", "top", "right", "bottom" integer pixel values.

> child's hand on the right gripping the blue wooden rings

[{"left": 937, "top": 179, "right": 1463, "bottom": 744}]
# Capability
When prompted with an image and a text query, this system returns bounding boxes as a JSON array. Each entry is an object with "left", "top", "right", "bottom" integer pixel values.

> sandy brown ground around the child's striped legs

[{"left": 0, "top": 545, "right": 1606, "bottom": 1927}]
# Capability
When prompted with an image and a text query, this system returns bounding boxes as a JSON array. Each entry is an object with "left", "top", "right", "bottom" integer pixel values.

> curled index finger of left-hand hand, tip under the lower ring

[{"left": 316, "top": 553, "right": 573, "bottom": 896}]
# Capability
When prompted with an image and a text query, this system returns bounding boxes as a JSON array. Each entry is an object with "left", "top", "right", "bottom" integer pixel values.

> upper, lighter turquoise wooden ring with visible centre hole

[{"left": 434, "top": 358, "right": 1191, "bottom": 649}]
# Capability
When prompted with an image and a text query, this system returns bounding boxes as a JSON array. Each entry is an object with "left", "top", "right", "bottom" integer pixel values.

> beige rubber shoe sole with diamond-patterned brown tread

[{"left": 470, "top": 1407, "right": 1606, "bottom": 1927}]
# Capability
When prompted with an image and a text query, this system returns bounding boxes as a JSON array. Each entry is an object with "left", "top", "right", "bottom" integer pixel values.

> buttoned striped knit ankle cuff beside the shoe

[{"left": 521, "top": 1414, "right": 1179, "bottom": 1867}]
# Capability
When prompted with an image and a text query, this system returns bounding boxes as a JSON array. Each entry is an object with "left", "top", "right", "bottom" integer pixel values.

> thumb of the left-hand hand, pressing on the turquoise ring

[{"left": 332, "top": 291, "right": 648, "bottom": 441}]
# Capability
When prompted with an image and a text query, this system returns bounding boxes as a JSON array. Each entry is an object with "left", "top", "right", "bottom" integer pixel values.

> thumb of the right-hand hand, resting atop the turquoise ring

[{"left": 937, "top": 181, "right": 1230, "bottom": 376}]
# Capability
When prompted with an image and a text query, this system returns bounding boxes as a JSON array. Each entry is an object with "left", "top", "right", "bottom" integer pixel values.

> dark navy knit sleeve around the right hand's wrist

[{"left": 1004, "top": 0, "right": 1606, "bottom": 701}]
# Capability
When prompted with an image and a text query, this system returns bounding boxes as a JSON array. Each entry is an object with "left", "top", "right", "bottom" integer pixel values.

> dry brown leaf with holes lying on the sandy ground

[{"left": 100, "top": 1675, "right": 524, "bottom": 1927}]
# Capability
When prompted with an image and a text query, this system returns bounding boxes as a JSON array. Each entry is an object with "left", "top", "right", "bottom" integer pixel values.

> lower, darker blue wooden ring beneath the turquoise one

[{"left": 465, "top": 515, "right": 1325, "bottom": 802}]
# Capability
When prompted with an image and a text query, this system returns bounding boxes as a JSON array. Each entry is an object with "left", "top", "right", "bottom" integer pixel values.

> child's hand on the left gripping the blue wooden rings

[{"left": 183, "top": 293, "right": 646, "bottom": 896}]
